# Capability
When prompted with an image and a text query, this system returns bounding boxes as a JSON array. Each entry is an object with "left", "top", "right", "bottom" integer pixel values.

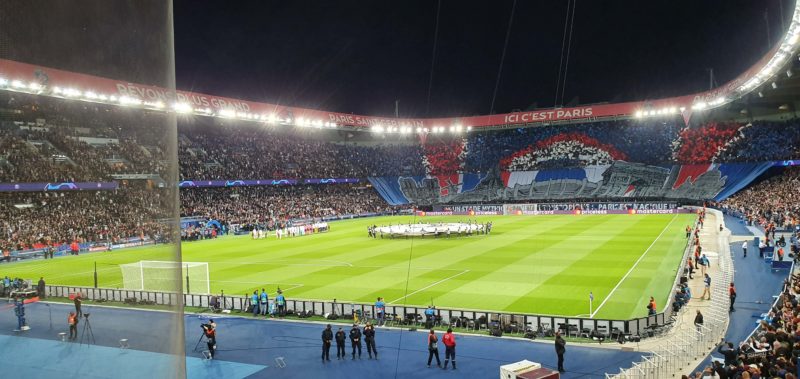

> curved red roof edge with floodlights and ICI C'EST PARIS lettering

[{"left": 0, "top": 4, "right": 800, "bottom": 134}]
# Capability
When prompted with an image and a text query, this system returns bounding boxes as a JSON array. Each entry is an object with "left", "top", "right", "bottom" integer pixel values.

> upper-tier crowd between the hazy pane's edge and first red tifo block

[{"left": 179, "top": 125, "right": 424, "bottom": 180}]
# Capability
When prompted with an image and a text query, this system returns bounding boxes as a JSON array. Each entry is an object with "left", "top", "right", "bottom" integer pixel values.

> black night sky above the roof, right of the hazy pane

[{"left": 175, "top": 0, "right": 793, "bottom": 117}]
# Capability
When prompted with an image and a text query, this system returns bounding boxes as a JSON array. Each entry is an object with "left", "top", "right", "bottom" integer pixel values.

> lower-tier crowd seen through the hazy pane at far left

[{"left": 0, "top": 189, "right": 173, "bottom": 254}]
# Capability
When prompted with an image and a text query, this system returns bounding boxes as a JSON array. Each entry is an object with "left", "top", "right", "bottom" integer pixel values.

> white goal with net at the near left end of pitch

[{"left": 119, "top": 261, "right": 211, "bottom": 294}]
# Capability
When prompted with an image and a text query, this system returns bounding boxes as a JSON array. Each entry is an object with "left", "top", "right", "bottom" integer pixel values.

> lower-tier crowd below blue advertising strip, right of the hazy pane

[{"left": 180, "top": 184, "right": 393, "bottom": 229}]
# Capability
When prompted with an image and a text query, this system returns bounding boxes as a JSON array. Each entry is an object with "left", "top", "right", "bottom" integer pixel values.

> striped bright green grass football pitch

[{"left": 0, "top": 214, "right": 694, "bottom": 319}]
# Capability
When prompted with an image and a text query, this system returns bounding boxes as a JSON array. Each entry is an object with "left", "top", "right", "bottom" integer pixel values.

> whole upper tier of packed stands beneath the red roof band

[{"left": 0, "top": 93, "right": 800, "bottom": 182}]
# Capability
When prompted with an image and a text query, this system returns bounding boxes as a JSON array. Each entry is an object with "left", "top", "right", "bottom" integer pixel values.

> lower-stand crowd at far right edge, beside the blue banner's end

[{"left": 719, "top": 167, "right": 800, "bottom": 228}]
